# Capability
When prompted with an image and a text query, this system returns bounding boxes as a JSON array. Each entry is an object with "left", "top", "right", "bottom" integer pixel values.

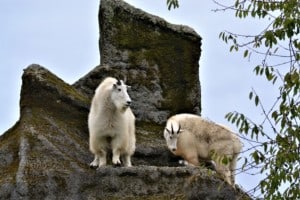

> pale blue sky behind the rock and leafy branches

[{"left": 0, "top": 0, "right": 276, "bottom": 197}]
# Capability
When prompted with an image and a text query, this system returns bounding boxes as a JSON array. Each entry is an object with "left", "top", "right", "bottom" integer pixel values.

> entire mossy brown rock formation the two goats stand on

[{"left": 0, "top": 0, "right": 248, "bottom": 199}]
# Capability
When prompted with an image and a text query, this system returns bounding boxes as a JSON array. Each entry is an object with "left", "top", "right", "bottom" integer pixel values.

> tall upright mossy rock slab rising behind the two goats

[{"left": 75, "top": 0, "right": 201, "bottom": 124}]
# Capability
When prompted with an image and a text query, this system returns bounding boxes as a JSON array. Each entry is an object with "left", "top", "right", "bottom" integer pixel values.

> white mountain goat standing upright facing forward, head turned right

[{"left": 88, "top": 77, "right": 136, "bottom": 167}]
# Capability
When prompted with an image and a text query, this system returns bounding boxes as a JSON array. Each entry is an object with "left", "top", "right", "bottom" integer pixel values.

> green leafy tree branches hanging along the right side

[{"left": 168, "top": 0, "right": 300, "bottom": 199}]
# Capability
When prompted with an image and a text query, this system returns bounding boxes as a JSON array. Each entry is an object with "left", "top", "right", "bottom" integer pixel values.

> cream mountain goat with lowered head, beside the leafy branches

[{"left": 164, "top": 114, "right": 242, "bottom": 186}]
